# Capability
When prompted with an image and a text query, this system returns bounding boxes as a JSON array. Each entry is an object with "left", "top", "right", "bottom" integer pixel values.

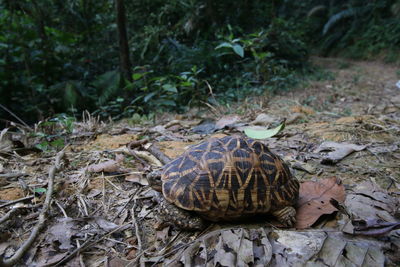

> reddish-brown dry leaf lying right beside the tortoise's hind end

[{"left": 296, "top": 177, "right": 346, "bottom": 229}]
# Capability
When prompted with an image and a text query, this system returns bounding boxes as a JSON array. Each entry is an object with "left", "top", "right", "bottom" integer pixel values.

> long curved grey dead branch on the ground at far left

[{"left": 0, "top": 147, "right": 66, "bottom": 266}]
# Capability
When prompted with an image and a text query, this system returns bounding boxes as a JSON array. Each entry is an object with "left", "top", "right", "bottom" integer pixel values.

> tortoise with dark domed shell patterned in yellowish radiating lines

[{"left": 148, "top": 136, "right": 299, "bottom": 229}]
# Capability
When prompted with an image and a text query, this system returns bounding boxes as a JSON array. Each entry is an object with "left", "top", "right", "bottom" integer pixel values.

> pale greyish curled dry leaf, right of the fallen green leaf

[{"left": 315, "top": 141, "right": 367, "bottom": 164}]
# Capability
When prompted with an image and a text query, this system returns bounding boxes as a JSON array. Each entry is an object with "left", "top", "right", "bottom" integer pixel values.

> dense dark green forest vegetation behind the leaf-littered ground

[{"left": 0, "top": 0, "right": 400, "bottom": 125}]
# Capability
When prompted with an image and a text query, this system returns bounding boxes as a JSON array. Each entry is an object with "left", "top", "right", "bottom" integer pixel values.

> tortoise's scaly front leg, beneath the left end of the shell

[{"left": 158, "top": 197, "right": 205, "bottom": 230}]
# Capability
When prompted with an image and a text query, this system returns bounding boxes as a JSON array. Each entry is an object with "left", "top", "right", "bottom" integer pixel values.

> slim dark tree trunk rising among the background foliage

[{"left": 115, "top": 0, "right": 132, "bottom": 81}]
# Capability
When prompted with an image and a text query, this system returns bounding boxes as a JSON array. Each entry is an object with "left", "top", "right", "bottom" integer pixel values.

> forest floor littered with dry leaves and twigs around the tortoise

[{"left": 0, "top": 58, "right": 400, "bottom": 266}]
